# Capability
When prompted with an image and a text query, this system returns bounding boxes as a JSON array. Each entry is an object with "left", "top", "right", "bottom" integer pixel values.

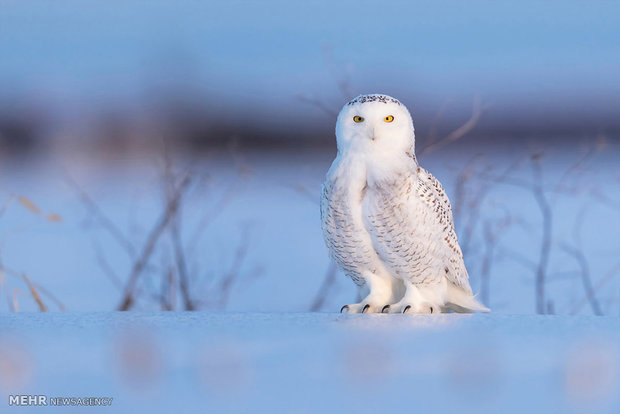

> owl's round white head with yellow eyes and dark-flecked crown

[{"left": 336, "top": 95, "right": 415, "bottom": 155}]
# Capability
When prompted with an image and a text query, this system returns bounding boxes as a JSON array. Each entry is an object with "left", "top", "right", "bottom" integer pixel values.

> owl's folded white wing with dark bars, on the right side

[{"left": 367, "top": 166, "right": 471, "bottom": 293}]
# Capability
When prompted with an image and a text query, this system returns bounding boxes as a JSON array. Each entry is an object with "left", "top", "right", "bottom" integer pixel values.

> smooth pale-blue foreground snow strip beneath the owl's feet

[{"left": 0, "top": 312, "right": 620, "bottom": 413}]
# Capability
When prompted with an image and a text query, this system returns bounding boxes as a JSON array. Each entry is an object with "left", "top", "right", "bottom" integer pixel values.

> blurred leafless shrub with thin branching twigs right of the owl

[{"left": 455, "top": 139, "right": 617, "bottom": 315}]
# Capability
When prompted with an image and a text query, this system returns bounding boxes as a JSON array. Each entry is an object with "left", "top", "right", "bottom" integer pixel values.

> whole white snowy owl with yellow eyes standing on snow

[{"left": 321, "top": 94, "right": 489, "bottom": 313}]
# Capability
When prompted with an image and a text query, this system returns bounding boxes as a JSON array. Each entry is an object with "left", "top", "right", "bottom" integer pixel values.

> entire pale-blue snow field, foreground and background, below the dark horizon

[{"left": 0, "top": 142, "right": 620, "bottom": 414}]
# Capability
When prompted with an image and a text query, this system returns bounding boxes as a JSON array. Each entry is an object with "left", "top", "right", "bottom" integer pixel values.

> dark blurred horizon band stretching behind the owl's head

[{"left": 0, "top": 93, "right": 620, "bottom": 154}]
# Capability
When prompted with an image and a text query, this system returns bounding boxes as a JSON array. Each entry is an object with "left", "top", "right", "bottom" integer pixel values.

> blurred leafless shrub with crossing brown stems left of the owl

[{"left": 68, "top": 143, "right": 256, "bottom": 311}]
